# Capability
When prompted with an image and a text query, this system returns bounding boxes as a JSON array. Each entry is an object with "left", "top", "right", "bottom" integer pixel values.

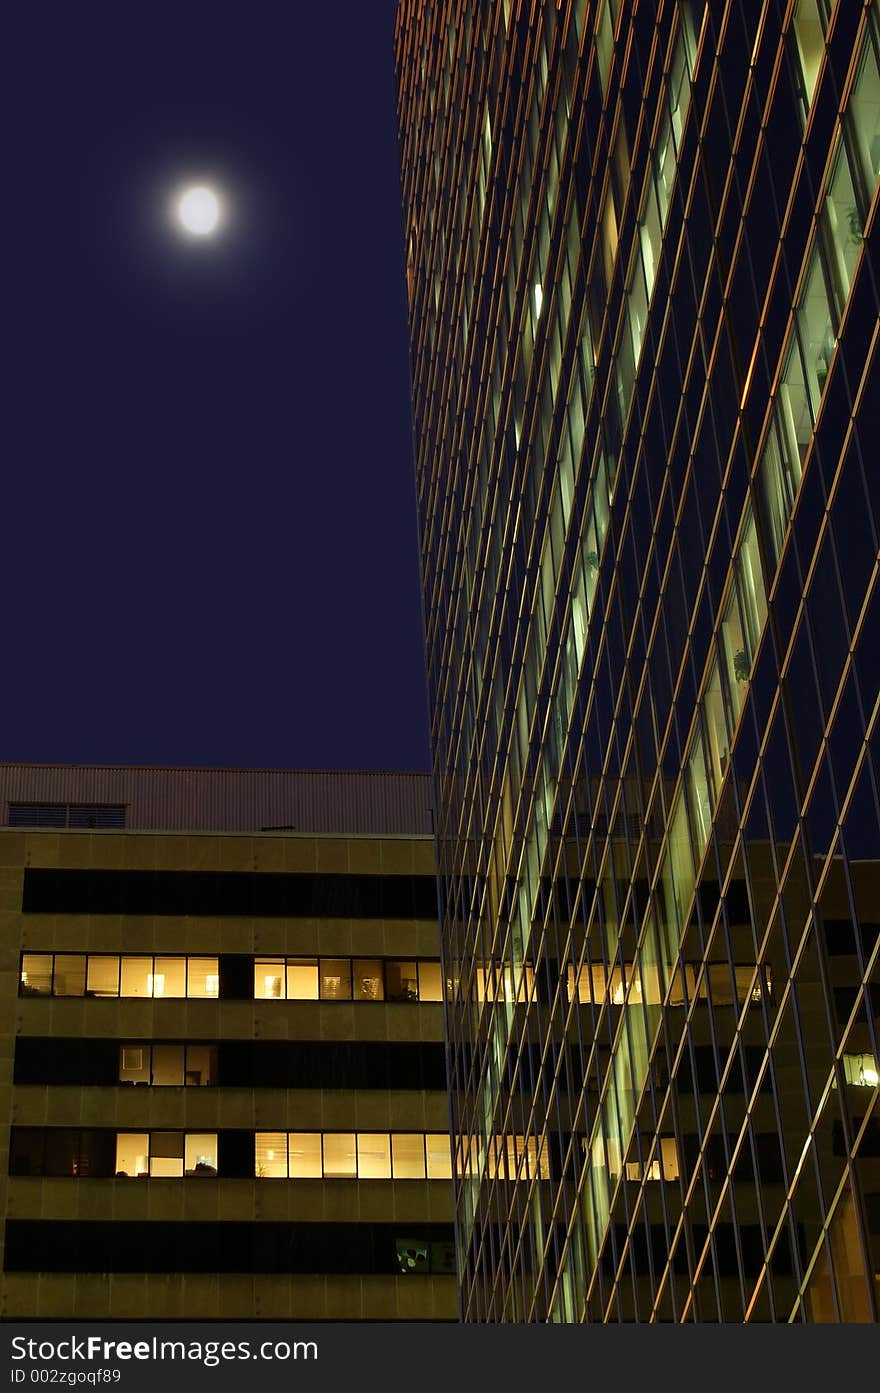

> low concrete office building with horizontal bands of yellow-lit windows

[{"left": 0, "top": 766, "right": 455, "bottom": 1321}]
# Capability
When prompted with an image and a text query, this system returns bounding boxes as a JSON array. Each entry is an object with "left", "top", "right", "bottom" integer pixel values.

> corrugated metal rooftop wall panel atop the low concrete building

[{"left": 0, "top": 763, "right": 433, "bottom": 836}]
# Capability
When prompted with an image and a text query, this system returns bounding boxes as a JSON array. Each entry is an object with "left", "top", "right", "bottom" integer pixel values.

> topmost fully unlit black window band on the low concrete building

[{"left": 21, "top": 868, "right": 437, "bottom": 919}]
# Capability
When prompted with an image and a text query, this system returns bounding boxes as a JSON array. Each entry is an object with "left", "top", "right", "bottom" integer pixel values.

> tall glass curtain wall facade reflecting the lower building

[{"left": 395, "top": 0, "right": 880, "bottom": 1322}]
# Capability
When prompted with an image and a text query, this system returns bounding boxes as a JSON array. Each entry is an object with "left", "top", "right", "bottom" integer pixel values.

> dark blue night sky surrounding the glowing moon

[{"left": 0, "top": 0, "right": 427, "bottom": 769}]
